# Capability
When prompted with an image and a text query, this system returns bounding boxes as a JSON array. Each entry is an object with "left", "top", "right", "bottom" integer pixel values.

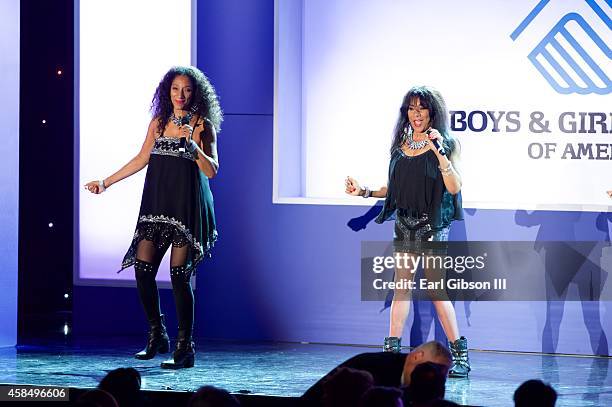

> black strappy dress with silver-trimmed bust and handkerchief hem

[{"left": 119, "top": 136, "right": 217, "bottom": 273}]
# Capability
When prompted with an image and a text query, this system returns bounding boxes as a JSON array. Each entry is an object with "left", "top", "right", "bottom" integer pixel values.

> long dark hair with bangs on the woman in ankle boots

[{"left": 390, "top": 86, "right": 457, "bottom": 156}]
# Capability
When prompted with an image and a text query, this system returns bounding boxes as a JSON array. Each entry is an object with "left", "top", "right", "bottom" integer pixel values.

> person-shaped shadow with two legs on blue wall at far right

[{"left": 514, "top": 210, "right": 612, "bottom": 356}]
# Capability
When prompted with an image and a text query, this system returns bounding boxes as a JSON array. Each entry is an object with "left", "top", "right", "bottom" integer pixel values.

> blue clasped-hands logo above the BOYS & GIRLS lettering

[{"left": 510, "top": 0, "right": 612, "bottom": 95}]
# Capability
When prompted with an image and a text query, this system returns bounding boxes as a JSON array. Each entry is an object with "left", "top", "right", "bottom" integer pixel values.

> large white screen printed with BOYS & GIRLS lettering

[{"left": 277, "top": 0, "right": 612, "bottom": 210}]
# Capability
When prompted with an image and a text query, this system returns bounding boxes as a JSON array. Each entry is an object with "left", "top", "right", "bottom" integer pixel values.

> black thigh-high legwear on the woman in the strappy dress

[{"left": 134, "top": 240, "right": 194, "bottom": 338}]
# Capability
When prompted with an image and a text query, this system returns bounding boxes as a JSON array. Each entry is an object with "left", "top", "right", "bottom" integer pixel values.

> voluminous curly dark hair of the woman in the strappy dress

[{"left": 151, "top": 66, "right": 223, "bottom": 133}]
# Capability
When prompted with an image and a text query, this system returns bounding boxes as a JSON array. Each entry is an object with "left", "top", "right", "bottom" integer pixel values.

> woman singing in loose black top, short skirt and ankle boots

[{"left": 345, "top": 86, "right": 470, "bottom": 377}]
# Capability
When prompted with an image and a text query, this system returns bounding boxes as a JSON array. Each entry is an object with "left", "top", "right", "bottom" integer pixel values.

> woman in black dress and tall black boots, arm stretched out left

[{"left": 85, "top": 67, "right": 223, "bottom": 369}]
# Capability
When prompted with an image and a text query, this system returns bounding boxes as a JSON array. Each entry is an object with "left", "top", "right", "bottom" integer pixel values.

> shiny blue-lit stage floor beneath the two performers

[{"left": 0, "top": 338, "right": 612, "bottom": 406}]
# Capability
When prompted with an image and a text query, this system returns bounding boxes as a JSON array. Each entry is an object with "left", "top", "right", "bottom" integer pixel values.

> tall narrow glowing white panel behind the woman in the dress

[{"left": 75, "top": 0, "right": 195, "bottom": 284}]
